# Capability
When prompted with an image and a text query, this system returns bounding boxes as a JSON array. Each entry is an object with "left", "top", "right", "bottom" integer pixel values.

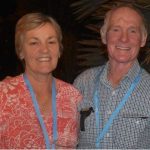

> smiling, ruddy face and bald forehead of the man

[{"left": 106, "top": 7, "right": 146, "bottom": 64}]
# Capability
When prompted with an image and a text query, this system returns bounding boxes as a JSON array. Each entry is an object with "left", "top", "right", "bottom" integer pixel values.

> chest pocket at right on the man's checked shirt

[{"left": 114, "top": 113, "right": 149, "bottom": 148}]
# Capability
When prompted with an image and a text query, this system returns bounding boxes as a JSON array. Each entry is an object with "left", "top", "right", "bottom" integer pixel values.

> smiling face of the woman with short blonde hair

[{"left": 20, "top": 23, "right": 60, "bottom": 74}]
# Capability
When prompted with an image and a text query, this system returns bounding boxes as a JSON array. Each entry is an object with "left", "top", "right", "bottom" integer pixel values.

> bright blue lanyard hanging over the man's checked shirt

[{"left": 94, "top": 70, "right": 142, "bottom": 148}]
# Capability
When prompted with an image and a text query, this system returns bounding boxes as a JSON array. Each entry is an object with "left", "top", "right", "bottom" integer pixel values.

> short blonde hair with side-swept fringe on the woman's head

[{"left": 15, "top": 13, "right": 63, "bottom": 59}]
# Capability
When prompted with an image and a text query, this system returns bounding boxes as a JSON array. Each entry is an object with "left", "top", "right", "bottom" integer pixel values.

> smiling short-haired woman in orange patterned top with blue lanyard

[{"left": 0, "top": 13, "right": 81, "bottom": 149}]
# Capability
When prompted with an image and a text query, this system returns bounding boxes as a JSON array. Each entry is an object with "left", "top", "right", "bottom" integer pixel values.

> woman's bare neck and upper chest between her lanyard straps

[{"left": 26, "top": 73, "right": 52, "bottom": 116}]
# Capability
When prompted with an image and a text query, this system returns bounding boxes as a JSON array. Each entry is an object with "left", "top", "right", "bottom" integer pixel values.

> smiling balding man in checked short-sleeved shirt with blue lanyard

[{"left": 74, "top": 6, "right": 150, "bottom": 149}]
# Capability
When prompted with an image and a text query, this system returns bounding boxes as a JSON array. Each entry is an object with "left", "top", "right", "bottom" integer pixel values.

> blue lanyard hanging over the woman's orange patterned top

[{"left": 23, "top": 74, "right": 57, "bottom": 149}]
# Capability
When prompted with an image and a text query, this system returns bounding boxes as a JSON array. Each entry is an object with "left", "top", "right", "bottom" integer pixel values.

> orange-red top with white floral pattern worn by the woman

[{"left": 0, "top": 75, "right": 82, "bottom": 149}]
